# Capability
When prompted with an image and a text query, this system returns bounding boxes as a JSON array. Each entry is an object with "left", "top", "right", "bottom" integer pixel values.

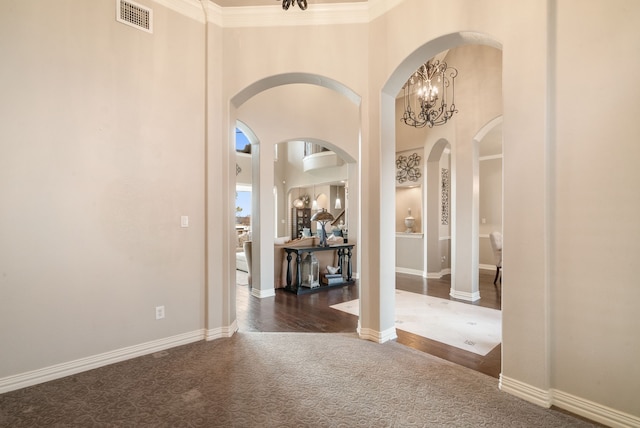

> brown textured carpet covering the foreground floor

[{"left": 0, "top": 333, "right": 591, "bottom": 427}]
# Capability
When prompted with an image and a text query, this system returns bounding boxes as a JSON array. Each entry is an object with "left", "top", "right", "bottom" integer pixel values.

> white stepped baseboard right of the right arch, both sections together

[{"left": 499, "top": 374, "right": 640, "bottom": 428}]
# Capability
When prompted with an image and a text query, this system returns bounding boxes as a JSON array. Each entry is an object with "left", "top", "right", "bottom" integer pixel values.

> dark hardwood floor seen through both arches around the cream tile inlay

[{"left": 236, "top": 271, "right": 501, "bottom": 378}]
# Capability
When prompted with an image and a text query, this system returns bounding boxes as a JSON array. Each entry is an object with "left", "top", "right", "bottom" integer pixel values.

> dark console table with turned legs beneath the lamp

[{"left": 284, "top": 244, "right": 355, "bottom": 294}]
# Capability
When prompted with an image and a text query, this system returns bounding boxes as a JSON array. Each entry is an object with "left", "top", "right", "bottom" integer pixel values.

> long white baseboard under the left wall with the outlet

[{"left": 0, "top": 329, "right": 204, "bottom": 394}]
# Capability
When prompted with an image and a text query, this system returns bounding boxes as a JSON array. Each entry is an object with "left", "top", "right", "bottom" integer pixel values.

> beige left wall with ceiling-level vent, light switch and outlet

[{"left": 0, "top": 0, "right": 205, "bottom": 379}]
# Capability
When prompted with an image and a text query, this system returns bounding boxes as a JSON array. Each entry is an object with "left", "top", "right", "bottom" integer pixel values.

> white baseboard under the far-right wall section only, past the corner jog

[{"left": 551, "top": 389, "right": 640, "bottom": 427}]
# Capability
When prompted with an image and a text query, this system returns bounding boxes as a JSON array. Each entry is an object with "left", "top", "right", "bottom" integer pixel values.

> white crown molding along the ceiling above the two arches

[{"left": 153, "top": 0, "right": 404, "bottom": 28}]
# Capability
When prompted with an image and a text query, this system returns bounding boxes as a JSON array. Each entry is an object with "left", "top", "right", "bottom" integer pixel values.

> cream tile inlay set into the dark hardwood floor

[{"left": 331, "top": 290, "right": 502, "bottom": 355}]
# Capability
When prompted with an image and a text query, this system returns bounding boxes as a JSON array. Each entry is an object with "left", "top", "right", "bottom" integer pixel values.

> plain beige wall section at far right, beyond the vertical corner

[{"left": 552, "top": 1, "right": 640, "bottom": 415}]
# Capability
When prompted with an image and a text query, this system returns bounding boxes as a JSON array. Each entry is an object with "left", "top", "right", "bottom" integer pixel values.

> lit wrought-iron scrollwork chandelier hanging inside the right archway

[{"left": 401, "top": 60, "right": 458, "bottom": 128}]
